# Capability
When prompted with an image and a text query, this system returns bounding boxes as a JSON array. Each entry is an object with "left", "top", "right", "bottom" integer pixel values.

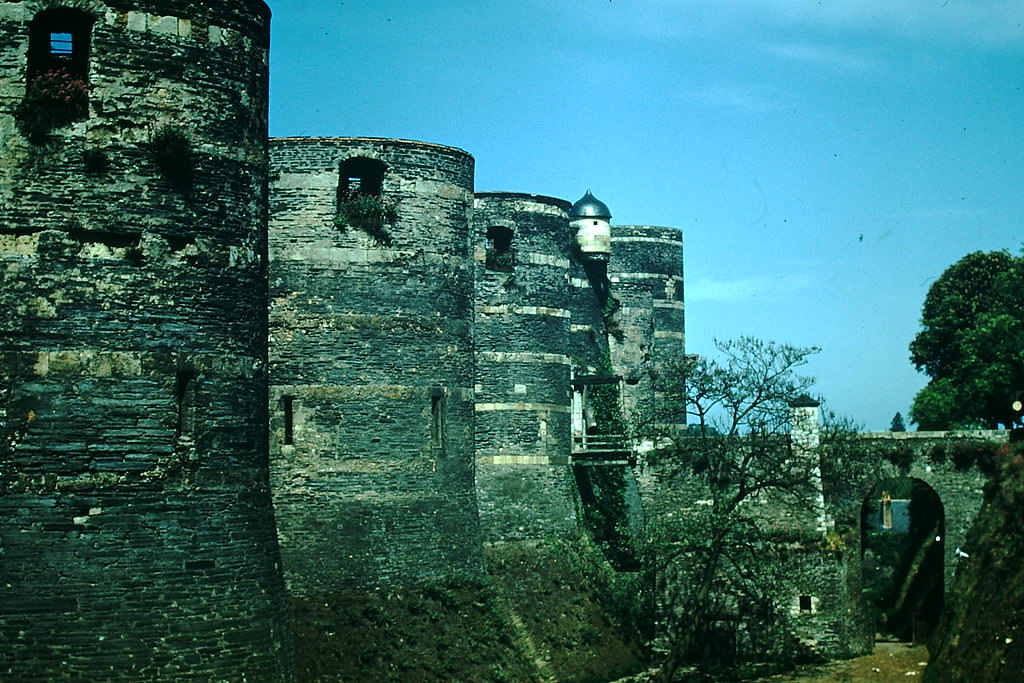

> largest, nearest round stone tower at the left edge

[{"left": 0, "top": 0, "right": 291, "bottom": 680}]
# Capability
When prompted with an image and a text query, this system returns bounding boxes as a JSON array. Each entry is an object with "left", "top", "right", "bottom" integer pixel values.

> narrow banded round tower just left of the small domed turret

[{"left": 474, "top": 193, "right": 577, "bottom": 542}]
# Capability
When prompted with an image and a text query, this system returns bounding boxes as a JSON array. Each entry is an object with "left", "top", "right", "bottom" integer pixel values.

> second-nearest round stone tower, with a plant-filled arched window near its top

[{"left": 269, "top": 138, "right": 482, "bottom": 599}]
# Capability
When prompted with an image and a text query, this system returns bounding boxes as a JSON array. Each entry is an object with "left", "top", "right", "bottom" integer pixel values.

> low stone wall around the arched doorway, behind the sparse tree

[{"left": 637, "top": 431, "right": 1008, "bottom": 657}]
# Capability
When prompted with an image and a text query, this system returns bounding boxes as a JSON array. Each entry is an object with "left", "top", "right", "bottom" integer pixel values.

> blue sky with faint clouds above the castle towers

[{"left": 268, "top": 0, "right": 1024, "bottom": 430}]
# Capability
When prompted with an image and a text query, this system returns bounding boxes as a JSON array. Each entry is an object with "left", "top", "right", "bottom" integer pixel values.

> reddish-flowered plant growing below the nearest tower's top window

[{"left": 15, "top": 69, "right": 89, "bottom": 139}]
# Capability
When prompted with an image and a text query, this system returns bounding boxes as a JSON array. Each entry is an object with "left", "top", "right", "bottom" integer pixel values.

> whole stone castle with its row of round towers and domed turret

[{"left": 0, "top": 0, "right": 683, "bottom": 679}]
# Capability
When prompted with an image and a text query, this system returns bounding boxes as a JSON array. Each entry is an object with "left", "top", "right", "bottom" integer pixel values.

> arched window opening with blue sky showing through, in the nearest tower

[{"left": 18, "top": 8, "right": 93, "bottom": 135}]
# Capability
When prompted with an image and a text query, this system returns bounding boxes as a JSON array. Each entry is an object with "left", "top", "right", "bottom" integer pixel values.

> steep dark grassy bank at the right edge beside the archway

[{"left": 925, "top": 444, "right": 1024, "bottom": 683}]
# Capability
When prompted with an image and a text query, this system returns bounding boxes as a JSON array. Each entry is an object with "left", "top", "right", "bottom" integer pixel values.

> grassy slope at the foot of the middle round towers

[{"left": 284, "top": 541, "right": 642, "bottom": 683}]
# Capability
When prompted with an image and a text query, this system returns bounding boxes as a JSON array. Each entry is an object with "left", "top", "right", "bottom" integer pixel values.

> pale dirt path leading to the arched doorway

[{"left": 755, "top": 643, "right": 928, "bottom": 683}]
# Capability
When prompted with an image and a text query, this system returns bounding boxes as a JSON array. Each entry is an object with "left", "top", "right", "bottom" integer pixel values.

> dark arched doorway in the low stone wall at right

[{"left": 860, "top": 477, "right": 946, "bottom": 643}]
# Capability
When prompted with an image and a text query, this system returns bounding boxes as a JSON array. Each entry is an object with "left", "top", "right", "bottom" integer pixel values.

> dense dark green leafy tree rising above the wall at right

[{"left": 910, "top": 251, "right": 1024, "bottom": 429}]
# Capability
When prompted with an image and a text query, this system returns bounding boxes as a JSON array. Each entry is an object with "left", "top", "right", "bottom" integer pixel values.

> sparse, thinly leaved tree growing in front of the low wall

[{"left": 641, "top": 337, "right": 820, "bottom": 681}]
